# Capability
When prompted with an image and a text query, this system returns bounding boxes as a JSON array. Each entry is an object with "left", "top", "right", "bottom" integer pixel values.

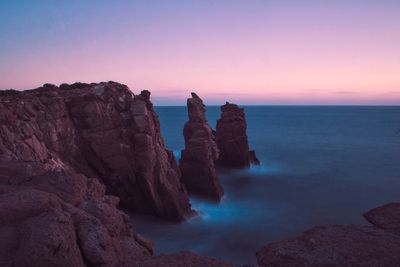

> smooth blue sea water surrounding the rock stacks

[{"left": 133, "top": 106, "right": 400, "bottom": 264}]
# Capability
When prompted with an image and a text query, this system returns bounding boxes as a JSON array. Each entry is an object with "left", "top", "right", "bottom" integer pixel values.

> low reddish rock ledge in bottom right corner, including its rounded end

[{"left": 256, "top": 203, "right": 400, "bottom": 267}]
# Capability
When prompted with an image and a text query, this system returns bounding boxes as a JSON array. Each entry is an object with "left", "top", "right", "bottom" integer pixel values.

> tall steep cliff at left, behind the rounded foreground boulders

[{"left": 0, "top": 82, "right": 191, "bottom": 220}]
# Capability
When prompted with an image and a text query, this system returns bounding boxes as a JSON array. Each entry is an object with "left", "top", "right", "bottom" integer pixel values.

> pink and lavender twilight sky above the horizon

[{"left": 0, "top": 0, "right": 400, "bottom": 105}]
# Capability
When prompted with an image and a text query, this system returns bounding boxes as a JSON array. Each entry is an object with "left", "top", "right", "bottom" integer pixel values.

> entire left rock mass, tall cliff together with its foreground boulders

[{"left": 0, "top": 82, "right": 239, "bottom": 267}]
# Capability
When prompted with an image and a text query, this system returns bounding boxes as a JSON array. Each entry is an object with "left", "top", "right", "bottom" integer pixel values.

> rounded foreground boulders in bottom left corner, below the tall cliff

[{"left": 0, "top": 180, "right": 151, "bottom": 267}]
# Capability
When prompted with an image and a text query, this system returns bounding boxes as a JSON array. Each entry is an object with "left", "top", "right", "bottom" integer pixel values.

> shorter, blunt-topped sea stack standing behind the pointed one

[{"left": 215, "top": 102, "right": 260, "bottom": 169}]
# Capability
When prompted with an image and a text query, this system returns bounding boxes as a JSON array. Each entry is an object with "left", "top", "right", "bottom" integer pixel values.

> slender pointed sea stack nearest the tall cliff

[{"left": 179, "top": 93, "right": 224, "bottom": 200}]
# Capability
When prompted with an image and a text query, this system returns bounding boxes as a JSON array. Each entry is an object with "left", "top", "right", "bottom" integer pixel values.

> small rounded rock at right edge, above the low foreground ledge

[{"left": 364, "top": 203, "right": 400, "bottom": 233}]
